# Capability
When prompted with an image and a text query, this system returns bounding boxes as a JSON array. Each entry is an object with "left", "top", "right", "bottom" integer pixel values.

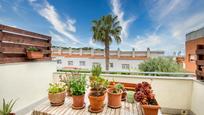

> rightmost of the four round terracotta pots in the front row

[{"left": 108, "top": 88, "right": 122, "bottom": 108}]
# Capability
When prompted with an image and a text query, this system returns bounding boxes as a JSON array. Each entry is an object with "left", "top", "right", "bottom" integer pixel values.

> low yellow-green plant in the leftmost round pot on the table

[{"left": 48, "top": 83, "right": 66, "bottom": 94}]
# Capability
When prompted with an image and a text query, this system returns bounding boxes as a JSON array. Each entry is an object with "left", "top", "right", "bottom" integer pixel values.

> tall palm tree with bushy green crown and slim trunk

[{"left": 92, "top": 15, "right": 122, "bottom": 71}]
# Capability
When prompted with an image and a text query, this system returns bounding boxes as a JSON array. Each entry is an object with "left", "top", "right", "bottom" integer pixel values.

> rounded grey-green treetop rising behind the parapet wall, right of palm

[{"left": 139, "top": 57, "right": 183, "bottom": 72}]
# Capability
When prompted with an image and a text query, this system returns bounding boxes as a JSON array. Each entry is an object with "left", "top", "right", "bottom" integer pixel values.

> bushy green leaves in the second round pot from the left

[{"left": 70, "top": 75, "right": 86, "bottom": 96}]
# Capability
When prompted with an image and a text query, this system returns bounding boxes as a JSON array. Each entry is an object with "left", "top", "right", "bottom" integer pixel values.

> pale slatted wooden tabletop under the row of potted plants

[{"left": 32, "top": 96, "right": 143, "bottom": 115}]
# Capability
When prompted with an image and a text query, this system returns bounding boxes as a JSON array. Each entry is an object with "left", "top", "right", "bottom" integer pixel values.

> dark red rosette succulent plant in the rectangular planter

[{"left": 135, "top": 82, "right": 157, "bottom": 105}]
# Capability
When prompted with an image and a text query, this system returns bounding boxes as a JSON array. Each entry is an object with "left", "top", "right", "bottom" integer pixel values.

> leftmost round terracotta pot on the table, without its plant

[{"left": 48, "top": 91, "right": 66, "bottom": 106}]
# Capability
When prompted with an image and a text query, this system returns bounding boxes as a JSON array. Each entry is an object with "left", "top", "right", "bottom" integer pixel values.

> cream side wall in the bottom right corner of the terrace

[{"left": 191, "top": 81, "right": 204, "bottom": 115}]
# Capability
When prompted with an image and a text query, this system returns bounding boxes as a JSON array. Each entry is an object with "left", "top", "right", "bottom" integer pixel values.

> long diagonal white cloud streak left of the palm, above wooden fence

[{"left": 29, "top": 0, "right": 80, "bottom": 43}]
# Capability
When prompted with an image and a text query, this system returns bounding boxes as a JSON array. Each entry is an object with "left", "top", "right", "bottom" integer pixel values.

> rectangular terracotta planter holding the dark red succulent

[{"left": 141, "top": 104, "right": 160, "bottom": 115}]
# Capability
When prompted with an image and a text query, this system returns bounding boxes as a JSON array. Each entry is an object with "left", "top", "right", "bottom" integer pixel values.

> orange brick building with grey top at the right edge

[{"left": 185, "top": 27, "right": 204, "bottom": 72}]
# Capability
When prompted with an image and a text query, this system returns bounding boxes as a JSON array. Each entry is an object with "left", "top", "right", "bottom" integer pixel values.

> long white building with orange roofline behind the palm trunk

[{"left": 52, "top": 48, "right": 164, "bottom": 71}]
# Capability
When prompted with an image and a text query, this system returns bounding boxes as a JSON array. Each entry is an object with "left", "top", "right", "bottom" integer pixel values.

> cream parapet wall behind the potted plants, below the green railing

[{"left": 54, "top": 72, "right": 197, "bottom": 115}]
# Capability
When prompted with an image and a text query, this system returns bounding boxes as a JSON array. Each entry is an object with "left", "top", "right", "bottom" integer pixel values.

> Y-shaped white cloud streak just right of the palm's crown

[{"left": 111, "top": 0, "right": 135, "bottom": 39}]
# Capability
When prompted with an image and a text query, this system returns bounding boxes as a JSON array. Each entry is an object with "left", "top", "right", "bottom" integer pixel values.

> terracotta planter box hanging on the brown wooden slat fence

[{"left": 26, "top": 51, "right": 43, "bottom": 59}]
